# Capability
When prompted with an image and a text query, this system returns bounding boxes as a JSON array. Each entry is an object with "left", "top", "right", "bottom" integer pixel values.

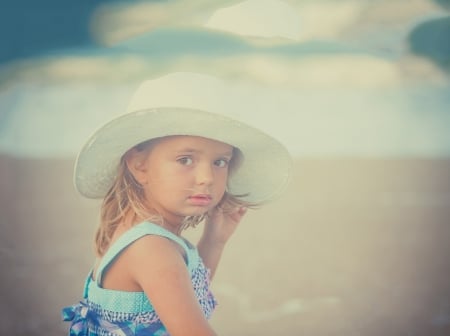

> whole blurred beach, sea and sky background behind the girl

[{"left": 0, "top": 0, "right": 450, "bottom": 336}]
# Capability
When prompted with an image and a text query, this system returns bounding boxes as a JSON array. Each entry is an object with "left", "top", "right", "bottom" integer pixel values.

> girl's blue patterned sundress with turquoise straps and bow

[{"left": 62, "top": 222, "right": 217, "bottom": 336}]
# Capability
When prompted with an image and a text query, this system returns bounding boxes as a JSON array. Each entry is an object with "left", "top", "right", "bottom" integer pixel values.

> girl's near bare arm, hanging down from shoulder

[{"left": 122, "top": 235, "right": 216, "bottom": 336}]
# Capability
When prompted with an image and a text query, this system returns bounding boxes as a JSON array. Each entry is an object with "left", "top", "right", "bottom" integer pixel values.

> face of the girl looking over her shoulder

[{"left": 129, "top": 136, "right": 233, "bottom": 224}]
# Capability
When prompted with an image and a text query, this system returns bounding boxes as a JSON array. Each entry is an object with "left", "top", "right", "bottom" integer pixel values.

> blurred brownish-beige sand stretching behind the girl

[{"left": 0, "top": 156, "right": 450, "bottom": 336}]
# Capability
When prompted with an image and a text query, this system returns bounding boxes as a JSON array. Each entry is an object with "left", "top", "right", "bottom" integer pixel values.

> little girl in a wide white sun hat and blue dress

[{"left": 63, "top": 79, "right": 291, "bottom": 336}]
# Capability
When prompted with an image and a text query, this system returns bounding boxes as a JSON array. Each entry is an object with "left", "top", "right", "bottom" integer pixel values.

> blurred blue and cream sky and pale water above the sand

[{"left": 0, "top": 0, "right": 450, "bottom": 158}]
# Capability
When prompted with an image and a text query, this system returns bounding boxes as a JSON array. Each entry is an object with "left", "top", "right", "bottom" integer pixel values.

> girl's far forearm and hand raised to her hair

[{"left": 197, "top": 207, "right": 247, "bottom": 279}]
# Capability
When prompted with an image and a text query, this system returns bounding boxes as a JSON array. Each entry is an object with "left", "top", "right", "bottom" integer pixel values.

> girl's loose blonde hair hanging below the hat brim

[{"left": 94, "top": 140, "right": 258, "bottom": 256}]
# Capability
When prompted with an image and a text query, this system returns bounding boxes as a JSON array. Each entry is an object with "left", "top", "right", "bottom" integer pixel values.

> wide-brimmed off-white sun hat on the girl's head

[{"left": 74, "top": 76, "right": 292, "bottom": 203}]
